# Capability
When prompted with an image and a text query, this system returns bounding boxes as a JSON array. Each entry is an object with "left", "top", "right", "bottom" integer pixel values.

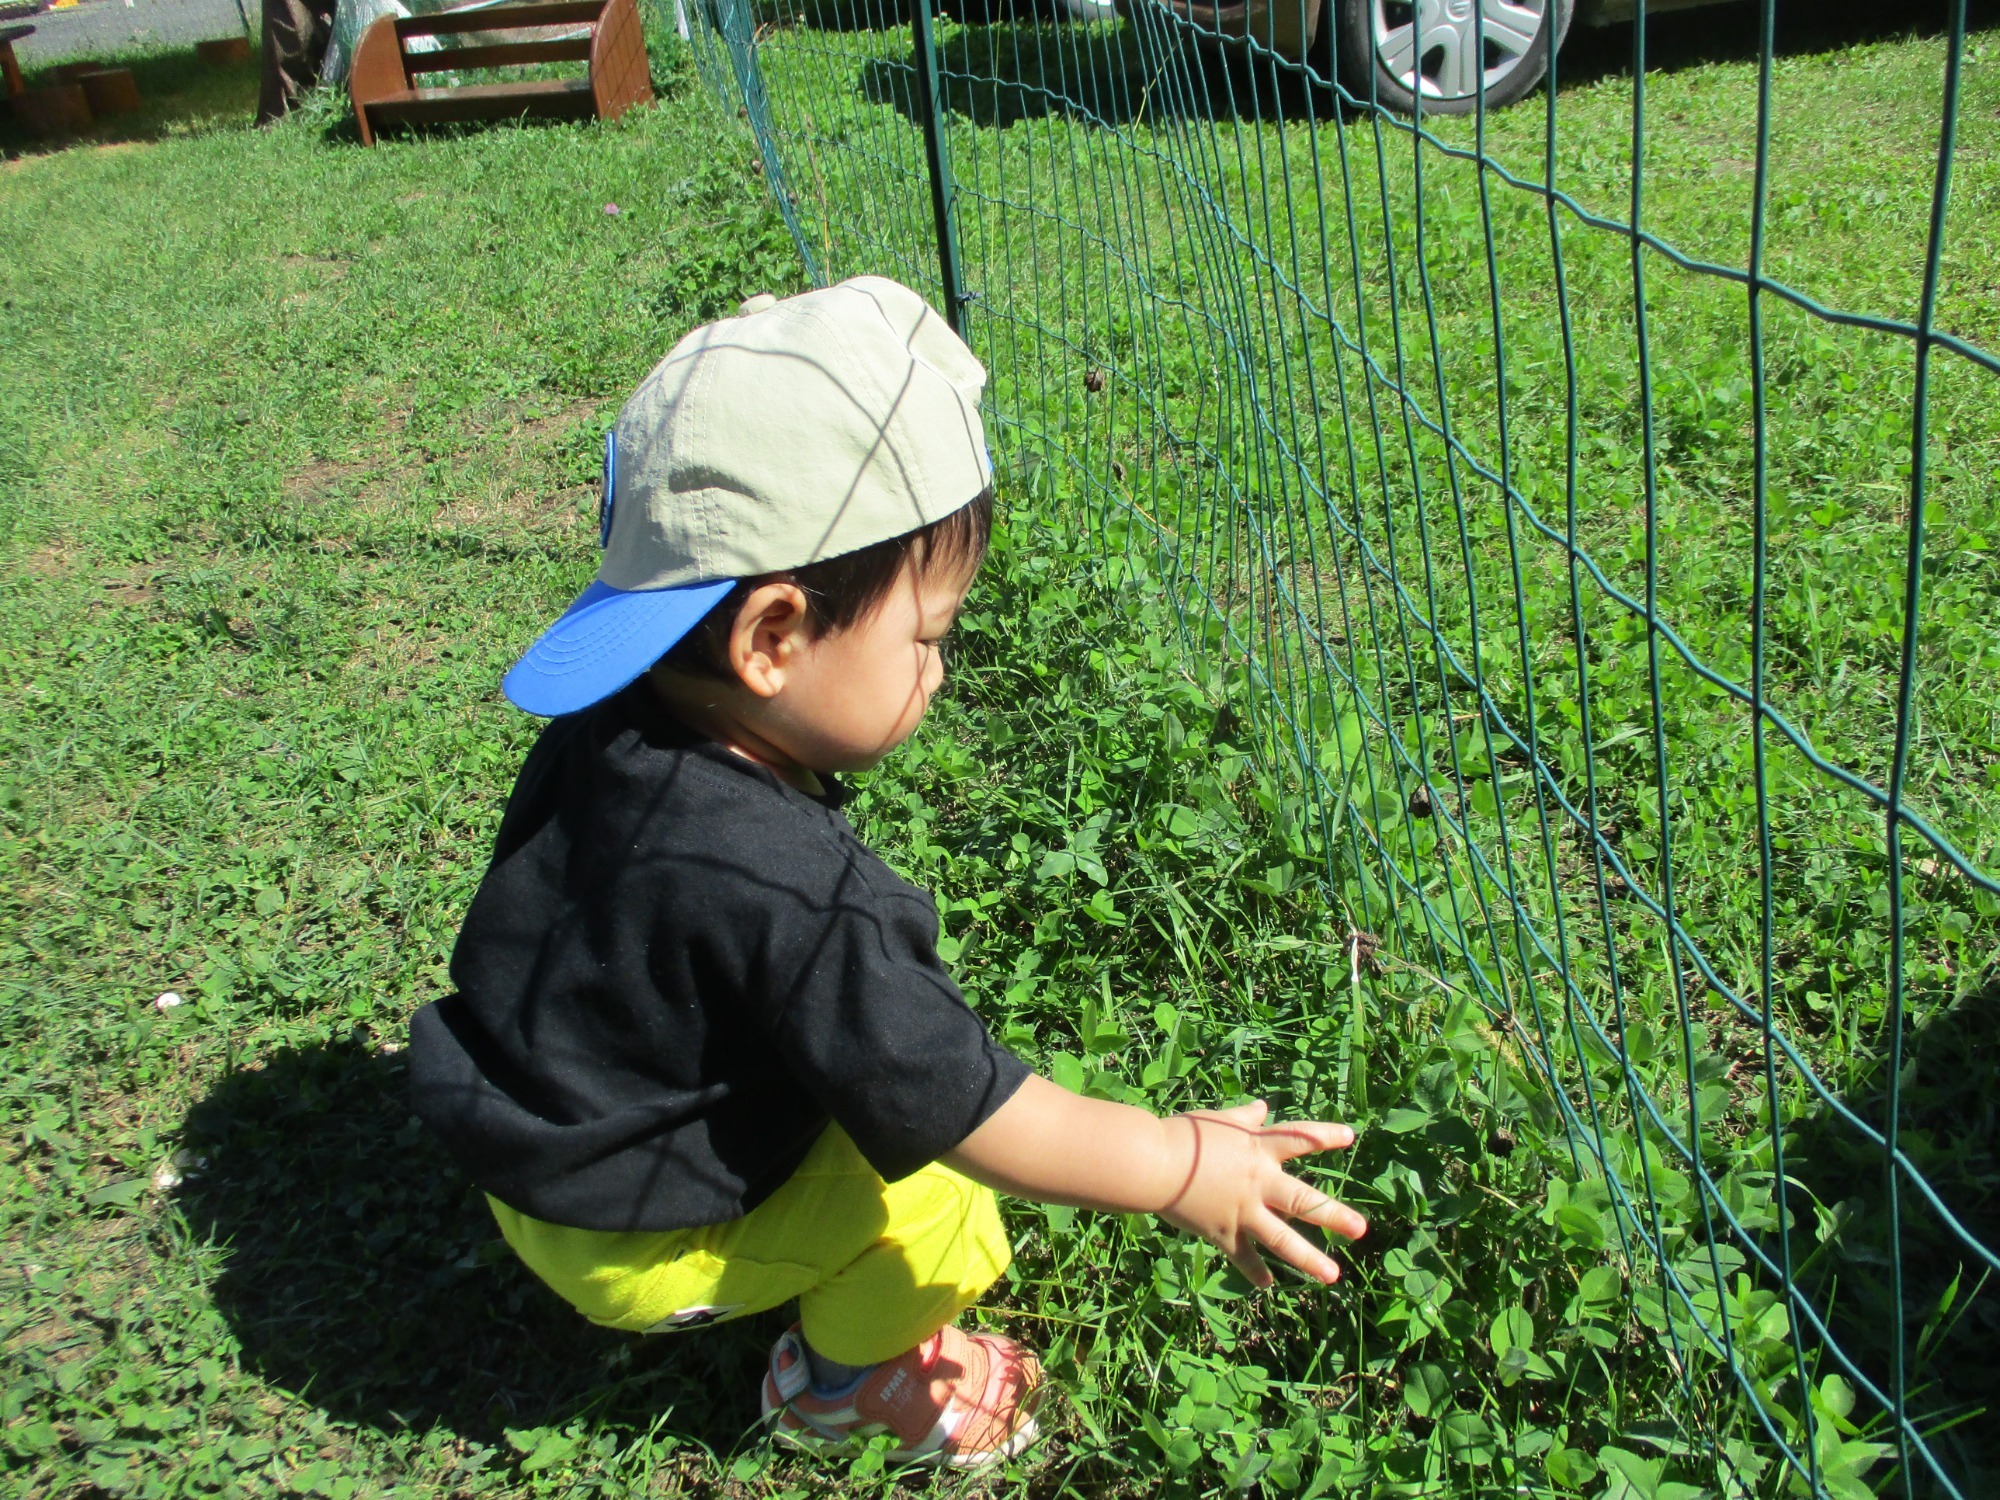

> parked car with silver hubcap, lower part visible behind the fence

[{"left": 1116, "top": 0, "right": 1716, "bottom": 114}]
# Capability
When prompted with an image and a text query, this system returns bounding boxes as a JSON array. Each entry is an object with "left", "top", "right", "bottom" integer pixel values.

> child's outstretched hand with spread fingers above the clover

[{"left": 1160, "top": 1100, "right": 1368, "bottom": 1286}]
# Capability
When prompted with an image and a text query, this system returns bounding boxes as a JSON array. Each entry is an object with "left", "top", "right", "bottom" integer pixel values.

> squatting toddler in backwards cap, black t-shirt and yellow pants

[{"left": 410, "top": 278, "right": 1366, "bottom": 1468}]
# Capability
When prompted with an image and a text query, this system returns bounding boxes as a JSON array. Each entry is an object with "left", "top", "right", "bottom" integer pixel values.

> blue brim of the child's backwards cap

[{"left": 500, "top": 578, "right": 736, "bottom": 718}]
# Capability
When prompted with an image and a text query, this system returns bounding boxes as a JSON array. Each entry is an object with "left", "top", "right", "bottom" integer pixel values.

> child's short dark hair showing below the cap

[{"left": 658, "top": 486, "right": 994, "bottom": 682}]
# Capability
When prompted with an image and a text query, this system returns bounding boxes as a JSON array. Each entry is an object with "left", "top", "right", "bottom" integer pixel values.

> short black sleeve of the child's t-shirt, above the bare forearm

[{"left": 770, "top": 864, "right": 1028, "bottom": 1182}]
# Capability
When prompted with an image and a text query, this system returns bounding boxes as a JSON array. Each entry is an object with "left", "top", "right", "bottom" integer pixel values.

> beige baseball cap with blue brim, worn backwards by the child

[{"left": 502, "top": 276, "right": 992, "bottom": 716}]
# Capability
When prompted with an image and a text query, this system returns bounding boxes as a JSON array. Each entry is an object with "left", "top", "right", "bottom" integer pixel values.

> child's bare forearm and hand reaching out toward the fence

[{"left": 944, "top": 1076, "right": 1368, "bottom": 1286}]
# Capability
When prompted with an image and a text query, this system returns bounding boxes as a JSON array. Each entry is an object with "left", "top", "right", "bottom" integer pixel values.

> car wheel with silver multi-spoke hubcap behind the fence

[{"left": 1336, "top": 0, "right": 1574, "bottom": 114}]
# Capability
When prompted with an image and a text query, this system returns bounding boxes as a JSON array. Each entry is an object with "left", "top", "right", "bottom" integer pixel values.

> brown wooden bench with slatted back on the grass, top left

[{"left": 348, "top": 0, "right": 652, "bottom": 146}]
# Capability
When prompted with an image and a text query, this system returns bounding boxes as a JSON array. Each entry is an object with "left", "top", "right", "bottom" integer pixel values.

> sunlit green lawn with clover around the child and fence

[{"left": 0, "top": 11, "right": 2000, "bottom": 1500}]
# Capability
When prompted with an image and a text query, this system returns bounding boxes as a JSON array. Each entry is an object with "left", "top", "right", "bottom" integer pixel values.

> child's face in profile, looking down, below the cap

[{"left": 770, "top": 558, "right": 978, "bottom": 772}]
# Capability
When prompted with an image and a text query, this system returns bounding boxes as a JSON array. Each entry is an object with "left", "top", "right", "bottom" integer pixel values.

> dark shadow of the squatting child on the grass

[{"left": 176, "top": 1042, "right": 772, "bottom": 1452}]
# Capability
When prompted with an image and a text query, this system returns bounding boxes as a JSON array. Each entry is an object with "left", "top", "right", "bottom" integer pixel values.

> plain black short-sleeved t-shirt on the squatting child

[{"left": 410, "top": 680, "right": 1028, "bottom": 1230}]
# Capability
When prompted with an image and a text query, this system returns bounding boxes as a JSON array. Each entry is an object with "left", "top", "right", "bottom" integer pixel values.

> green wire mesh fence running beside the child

[{"left": 682, "top": 0, "right": 2000, "bottom": 1500}]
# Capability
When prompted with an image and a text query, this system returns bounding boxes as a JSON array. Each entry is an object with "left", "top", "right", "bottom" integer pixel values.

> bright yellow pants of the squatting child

[{"left": 486, "top": 1126, "right": 1014, "bottom": 1364}]
